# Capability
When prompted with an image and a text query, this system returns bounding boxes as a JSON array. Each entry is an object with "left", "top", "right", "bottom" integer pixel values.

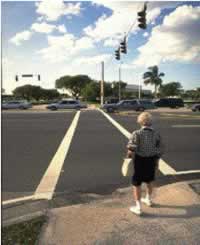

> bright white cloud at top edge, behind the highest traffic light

[{"left": 84, "top": 0, "right": 180, "bottom": 45}]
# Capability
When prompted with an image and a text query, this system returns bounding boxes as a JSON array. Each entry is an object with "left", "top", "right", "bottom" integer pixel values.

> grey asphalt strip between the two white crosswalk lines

[{"left": 56, "top": 111, "right": 129, "bottom": 196}]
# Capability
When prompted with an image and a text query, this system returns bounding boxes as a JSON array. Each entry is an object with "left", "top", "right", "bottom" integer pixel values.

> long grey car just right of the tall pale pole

[{"left": 101, "top": 99, "right": 156, "bottom": 112}]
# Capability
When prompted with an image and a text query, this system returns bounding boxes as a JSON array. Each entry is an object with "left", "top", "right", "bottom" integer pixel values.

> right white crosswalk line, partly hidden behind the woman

[{"left": 98, "top": 109, "right": 177, "bottom": 175}]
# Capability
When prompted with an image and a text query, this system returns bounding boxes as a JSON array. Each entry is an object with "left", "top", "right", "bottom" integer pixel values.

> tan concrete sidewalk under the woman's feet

[{"left": 40, "top": 182, "right": 200, "bottom": 245}]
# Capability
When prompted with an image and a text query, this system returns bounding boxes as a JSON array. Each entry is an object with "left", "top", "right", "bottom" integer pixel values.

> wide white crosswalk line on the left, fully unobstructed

[{"left": 34, "top": 111, "right": 80, "bottom": 200}]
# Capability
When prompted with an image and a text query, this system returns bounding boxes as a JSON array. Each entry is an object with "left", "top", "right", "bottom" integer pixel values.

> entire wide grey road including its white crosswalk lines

[{"left": 2, "top": 110, "right": 200, "bottom": 203}]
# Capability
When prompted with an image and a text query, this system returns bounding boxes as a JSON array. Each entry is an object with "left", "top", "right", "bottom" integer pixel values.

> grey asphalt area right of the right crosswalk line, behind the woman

[{"left": 112, "top": 111, "right": 200, "bottom": 171}]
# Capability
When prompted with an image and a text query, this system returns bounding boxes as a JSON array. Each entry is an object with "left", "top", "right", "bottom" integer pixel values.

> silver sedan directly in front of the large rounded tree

[{"left": 46, "top": 99, "right": 87, "bottom": 110}]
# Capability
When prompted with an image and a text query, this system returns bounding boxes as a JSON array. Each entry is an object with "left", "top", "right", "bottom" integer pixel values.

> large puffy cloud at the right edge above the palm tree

[{"left": 134, "top": 5, "right": 200, "bottom": 66}]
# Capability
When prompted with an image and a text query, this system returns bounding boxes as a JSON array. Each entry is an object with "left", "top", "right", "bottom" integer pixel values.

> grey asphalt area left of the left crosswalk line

[{"left": 2, "top": 112, "right": 75, "bottom": 200}]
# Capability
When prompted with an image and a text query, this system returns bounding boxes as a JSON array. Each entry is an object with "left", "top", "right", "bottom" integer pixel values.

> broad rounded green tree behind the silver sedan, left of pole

[{"left": 55, "top": 75, "right": 92, "bottom": 98}]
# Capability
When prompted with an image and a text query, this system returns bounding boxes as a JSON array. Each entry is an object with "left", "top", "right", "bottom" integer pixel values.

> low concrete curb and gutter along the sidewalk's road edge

[{"left": 2, "top": 174, "right": 200, "bottom": 227}]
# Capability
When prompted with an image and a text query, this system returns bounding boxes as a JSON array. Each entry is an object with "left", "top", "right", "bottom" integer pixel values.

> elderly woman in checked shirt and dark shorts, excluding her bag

[{"left": 127, "top": 112, "right": 163, "bottom": 215}]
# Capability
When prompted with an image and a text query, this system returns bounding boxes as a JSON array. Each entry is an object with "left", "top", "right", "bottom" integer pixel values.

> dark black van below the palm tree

[{"left": 154, "top": 98, "right": 184, "bottom": 108}]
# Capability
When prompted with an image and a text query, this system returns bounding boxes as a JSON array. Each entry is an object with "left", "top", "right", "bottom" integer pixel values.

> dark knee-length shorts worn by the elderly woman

[{"left": 132, "top": 155, "right": 159, "bottom": 186}]
